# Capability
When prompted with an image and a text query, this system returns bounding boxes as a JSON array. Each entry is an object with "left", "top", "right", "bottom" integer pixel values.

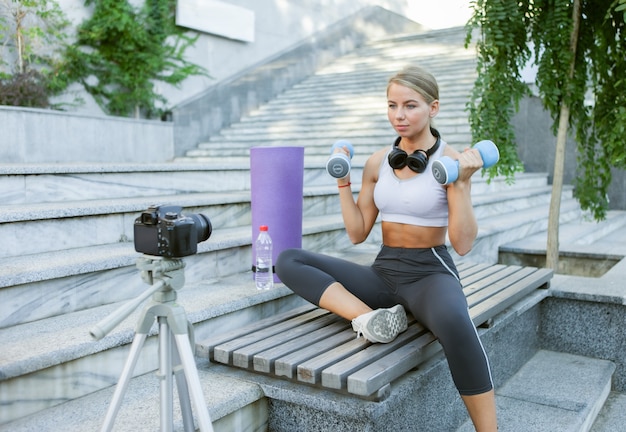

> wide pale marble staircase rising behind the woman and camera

[{"left": 0, "top": 25, "right": 624, "bottom": 432}]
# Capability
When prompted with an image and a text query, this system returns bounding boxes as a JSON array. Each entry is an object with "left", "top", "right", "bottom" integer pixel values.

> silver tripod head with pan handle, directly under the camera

[{"left": 89, "top": 255, "right": 185, "bottom": 339}]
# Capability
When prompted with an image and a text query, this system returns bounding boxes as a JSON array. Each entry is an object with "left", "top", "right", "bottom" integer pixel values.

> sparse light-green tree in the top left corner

[{"left": 0, "top": 0, "right": 70, "bottom": 108}]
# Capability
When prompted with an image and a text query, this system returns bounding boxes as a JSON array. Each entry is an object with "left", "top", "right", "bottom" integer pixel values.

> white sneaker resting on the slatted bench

[{"left": 352, "top": 305, "right": 407, "bottom": 343}]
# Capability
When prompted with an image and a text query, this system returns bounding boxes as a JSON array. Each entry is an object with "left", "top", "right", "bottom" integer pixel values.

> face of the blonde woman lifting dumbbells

[{"left": 387, "top": 83, "right": 439, "bottom": 138}]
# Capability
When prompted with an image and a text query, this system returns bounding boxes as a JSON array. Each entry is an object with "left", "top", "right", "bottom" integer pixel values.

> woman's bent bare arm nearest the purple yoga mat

[{"left": 338, "top": 149, "right": 385, "bottom": 244}]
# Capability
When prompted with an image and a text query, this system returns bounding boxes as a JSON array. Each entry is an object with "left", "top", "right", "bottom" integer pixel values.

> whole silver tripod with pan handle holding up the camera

[{"left": 90, "top": 256, "right": 213, "bottom": 432}]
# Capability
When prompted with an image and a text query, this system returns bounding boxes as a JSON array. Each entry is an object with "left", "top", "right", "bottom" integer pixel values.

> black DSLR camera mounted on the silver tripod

[{"left": 135, "top": 206, "right": 212, "bottom": 258}]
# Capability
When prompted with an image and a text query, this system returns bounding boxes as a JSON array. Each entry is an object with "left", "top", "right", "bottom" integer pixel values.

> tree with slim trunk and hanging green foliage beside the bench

[{"left": 466, "top": 0, "right": 626, "bottom": 269}]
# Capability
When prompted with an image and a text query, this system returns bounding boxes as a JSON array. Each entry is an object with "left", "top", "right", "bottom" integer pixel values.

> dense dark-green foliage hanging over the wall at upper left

[{"left": 66, "top": 0, "right": 206, "bottom": 118}]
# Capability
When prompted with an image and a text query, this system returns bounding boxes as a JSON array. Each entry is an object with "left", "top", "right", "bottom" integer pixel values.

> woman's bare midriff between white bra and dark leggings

[{"left": 382, "top": 222, "right": 447, "bottom": 249}]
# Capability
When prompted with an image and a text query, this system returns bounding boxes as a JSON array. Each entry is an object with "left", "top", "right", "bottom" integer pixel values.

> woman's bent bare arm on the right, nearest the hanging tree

[{"left": 447, "top": 149, "right": 483, "bottom": 255}]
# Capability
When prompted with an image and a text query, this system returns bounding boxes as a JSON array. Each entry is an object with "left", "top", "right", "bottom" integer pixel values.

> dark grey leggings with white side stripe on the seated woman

[{"left": 276, "top": 246, "right": 493, "bottom": 395}]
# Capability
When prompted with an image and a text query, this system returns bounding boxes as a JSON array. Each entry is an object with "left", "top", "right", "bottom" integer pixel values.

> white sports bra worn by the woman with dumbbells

[{"left": 374, "top": 140, "right": 448, "bottom": 227}]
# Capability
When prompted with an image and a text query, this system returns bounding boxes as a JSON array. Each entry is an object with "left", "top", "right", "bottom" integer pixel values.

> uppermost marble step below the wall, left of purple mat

[{"left": 0, "top": 164, "right": 250, "bottom": 206}]
